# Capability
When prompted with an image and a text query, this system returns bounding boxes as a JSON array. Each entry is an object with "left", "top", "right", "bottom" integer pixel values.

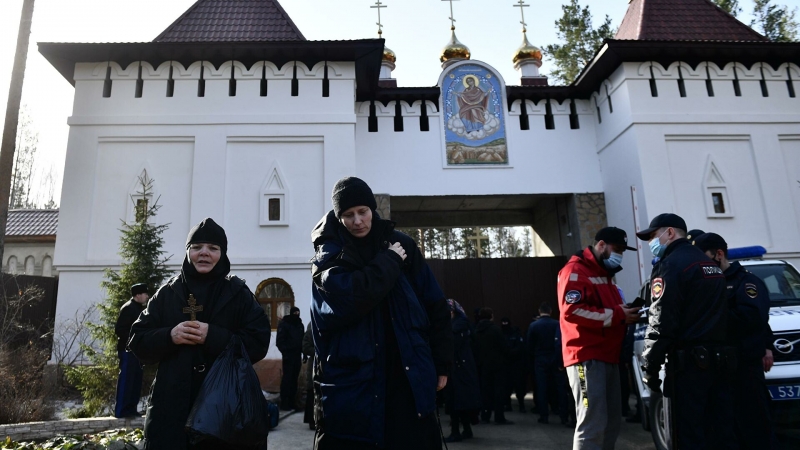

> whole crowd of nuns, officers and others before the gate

[{"left": 109, "top": 177, "right": 777, "bottom": 450}]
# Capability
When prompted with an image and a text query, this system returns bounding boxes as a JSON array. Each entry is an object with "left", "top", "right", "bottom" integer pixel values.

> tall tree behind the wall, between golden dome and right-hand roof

[{"left": 544, "top": 0, "right": 614, "bottom": 84}]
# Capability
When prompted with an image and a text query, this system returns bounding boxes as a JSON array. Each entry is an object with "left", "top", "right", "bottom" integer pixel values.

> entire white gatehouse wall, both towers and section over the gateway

[{"left": 54, "top": 53, "right": 800, "bottom": 357}]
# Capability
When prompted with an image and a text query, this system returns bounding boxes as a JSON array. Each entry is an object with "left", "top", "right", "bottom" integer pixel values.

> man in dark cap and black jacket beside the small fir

[{"left": 114, "top": 283, "right": 150, "bottom": 417}]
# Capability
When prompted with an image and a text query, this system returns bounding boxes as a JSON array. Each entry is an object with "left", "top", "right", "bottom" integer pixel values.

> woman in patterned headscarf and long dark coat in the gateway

[{"left": 445, "top": 299, "right": 481, "bottom": 442}]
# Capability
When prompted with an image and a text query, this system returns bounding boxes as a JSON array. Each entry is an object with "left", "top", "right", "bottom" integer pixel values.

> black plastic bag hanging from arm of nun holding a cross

[{"left": 186, "top": 336, "right": 269, "bottom": 448}]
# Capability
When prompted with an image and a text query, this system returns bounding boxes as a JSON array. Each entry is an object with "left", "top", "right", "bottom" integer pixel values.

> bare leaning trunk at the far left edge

[{"left": 0, "top": 0, "right": 34, "bottom": 267}]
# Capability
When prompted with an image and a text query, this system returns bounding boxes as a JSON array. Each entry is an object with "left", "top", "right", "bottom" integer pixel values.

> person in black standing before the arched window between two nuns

[{"left": 275, "top": 306, "right": 305, "bottom": 410}]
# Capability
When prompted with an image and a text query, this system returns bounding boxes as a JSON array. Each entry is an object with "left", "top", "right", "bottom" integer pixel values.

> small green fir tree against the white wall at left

[{"left": 66, "top": 172, "right": 170, "bottom": 416}]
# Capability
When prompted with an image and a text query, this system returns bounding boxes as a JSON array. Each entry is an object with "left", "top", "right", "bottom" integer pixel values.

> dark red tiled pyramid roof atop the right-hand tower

[{"left": 614, "top": 0, "right": 769, "bottom": 41}]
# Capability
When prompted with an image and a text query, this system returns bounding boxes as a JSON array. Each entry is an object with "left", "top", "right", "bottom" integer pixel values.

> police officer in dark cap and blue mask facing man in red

[{"left": 636, "top": 214, "right": 738, "bottom": 450}]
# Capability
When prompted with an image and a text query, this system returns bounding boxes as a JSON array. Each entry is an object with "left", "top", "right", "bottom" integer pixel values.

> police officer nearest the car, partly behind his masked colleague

[{"left": 694, "top": 233, "right": 775, "bottom": 449}]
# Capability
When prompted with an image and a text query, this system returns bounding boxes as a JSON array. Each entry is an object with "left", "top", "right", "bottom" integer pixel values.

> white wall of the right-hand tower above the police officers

[{"left": 598, "top": 62, "right": 800, "bottom": 295}]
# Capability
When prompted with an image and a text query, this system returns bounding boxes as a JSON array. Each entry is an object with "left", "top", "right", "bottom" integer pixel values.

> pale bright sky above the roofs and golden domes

[{"left": 0, "top": 0, "right": 800, "bottom": 200}]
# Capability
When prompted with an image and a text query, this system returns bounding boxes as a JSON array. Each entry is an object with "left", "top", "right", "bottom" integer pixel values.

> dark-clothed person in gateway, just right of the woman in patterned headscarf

[{"left": 475, "top": 308, "right": 513, "bottom": 425}]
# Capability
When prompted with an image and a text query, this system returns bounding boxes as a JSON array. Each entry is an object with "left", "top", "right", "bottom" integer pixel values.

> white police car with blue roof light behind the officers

[{"left": 633, "top": 247, "right": 800, "bottom": 450}]
